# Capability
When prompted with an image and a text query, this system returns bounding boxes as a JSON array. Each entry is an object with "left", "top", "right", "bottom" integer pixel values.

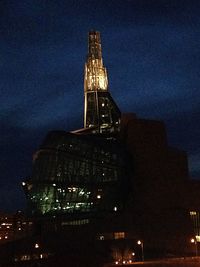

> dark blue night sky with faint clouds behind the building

[{"left": 0, "top": 0, "right": 200, "bottom": 214}]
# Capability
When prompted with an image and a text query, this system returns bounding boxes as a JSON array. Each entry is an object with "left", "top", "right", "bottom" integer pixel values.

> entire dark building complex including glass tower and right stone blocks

[{"left": 0, "top": 31, "right": 200, "bottom": 267}]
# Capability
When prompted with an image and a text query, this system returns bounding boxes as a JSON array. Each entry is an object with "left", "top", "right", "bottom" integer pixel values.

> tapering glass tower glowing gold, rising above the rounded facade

[{"left": 84, "top": 31, "right": 121, "bottom": 133}]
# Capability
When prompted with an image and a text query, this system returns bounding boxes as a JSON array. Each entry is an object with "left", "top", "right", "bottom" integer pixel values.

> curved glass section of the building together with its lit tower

[{"left": 23, "top": 32, "right": 129, "bottom": 222}]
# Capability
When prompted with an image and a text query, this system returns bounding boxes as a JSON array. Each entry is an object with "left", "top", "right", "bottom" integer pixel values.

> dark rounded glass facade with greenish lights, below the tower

[{"left": 23, "top": 131, "right": 126, "bottom": 218}]
